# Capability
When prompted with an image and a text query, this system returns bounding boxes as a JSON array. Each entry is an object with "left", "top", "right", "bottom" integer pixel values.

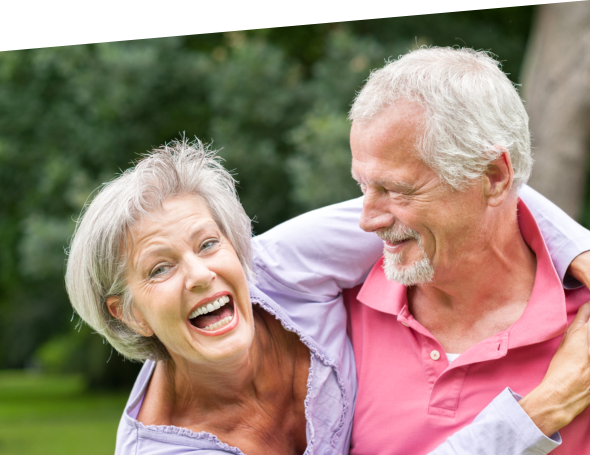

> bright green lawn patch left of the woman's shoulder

[{"left": 0, "top": 370, "right": 128, "bottom": 455}]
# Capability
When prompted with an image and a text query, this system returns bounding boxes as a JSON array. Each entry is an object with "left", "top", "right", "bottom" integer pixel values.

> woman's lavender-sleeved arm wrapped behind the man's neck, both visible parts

[{"left": 254, "top": 185, "right": 590, "bottom": 303}]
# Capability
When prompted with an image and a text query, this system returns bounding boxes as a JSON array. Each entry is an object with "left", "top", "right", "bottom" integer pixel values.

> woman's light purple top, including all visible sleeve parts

[{"left": 116, "top": 184, "right": 590, "bottom": 455}]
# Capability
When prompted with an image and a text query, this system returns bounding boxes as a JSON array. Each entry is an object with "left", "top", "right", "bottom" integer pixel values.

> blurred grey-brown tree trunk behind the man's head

[{"left": 523, "top": 0, "right": 590, "bottom": 218}]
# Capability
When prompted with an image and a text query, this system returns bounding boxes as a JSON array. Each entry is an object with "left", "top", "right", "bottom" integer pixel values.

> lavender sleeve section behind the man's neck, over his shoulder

[{"left": 518, "top": 185, "right": 590, "bottom": 289}]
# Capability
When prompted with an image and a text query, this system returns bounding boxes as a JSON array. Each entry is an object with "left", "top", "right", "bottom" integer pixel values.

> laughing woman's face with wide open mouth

[{"left": 122, "top": 196, "right": 254, "bottom": 364}]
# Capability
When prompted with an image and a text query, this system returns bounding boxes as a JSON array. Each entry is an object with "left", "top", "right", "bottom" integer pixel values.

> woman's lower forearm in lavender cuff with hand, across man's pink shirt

[{"left": 430, "top": 303, "right": 590, "bottom": 455}]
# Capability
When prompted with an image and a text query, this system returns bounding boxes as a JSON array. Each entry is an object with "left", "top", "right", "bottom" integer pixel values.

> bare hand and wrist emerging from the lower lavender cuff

[{"left": 519, "top": 302, "right": 590, "bottom": 436}]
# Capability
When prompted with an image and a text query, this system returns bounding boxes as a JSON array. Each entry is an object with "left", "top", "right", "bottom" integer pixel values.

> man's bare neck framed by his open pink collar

[{"left": 408, "top": 203, "right": 536, "bottom": 353}]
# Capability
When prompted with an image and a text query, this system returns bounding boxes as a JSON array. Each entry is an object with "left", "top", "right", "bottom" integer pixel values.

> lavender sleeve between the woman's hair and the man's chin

[{"left": 253, "top": 197, "right": 383, "bottom": 303}]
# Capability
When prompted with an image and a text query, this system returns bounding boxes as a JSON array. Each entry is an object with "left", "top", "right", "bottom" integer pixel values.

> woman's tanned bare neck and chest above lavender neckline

[{"left": 137, "top": 306, "right": 310, "bottom": 455}]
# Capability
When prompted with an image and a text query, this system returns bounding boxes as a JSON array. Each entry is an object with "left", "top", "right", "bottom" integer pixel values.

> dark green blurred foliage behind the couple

[{"left": 0, "top": 6, "right": 533, "bottom": 387}]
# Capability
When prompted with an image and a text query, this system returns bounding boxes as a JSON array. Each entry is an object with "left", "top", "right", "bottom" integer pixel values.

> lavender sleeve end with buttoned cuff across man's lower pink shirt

[{"left": 430, "top": 388, "right": 561, "bottom": 455}]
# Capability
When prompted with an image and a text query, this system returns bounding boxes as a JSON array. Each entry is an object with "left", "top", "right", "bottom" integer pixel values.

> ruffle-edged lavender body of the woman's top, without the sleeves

[{"left": 115, "top": 287, "right": 356, "bottom": 455}]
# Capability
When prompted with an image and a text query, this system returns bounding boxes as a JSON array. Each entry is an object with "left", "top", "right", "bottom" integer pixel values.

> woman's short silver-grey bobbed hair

[{"left": 65, "top": 139, "right": 252, "bottom": 361}]
